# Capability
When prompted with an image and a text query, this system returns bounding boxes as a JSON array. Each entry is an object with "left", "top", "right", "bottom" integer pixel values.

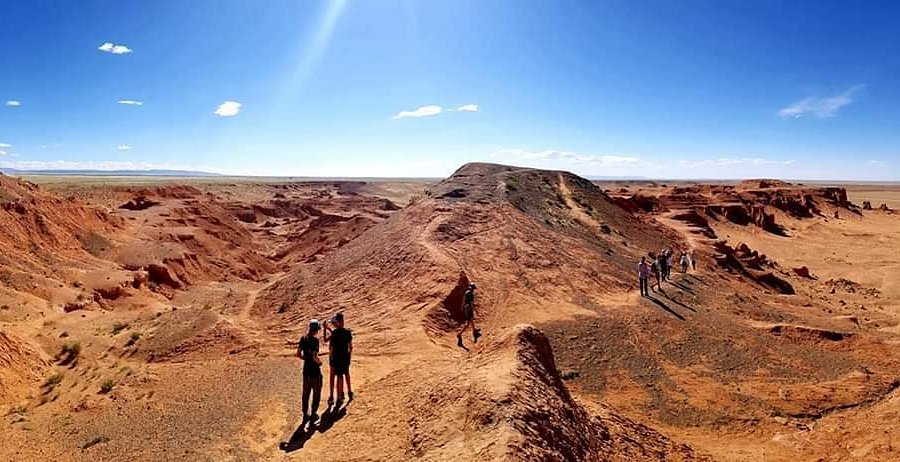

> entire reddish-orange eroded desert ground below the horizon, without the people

[{"left": 0, "top": 164, "right": 900, "bottom": 461}]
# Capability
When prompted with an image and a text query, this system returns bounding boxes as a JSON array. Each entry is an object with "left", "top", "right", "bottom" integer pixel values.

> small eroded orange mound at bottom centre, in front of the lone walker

[{"left": 411, "top": 325, "right": 702, "bottom": 461}]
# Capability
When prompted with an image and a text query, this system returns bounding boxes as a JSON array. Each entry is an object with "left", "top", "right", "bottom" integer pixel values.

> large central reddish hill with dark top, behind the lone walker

[{"left": 256, "top": 164, "right": 678, "bottom": 326}]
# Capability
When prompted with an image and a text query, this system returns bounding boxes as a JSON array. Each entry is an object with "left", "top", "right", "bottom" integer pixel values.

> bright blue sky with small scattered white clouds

[{"left": 0, "top": 0, "right": 900, "bottom": 180}]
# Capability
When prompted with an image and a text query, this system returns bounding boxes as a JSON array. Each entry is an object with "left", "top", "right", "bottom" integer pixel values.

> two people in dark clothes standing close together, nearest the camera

[{"left": 297, "top": 311, "right": 353, "bottom": 425}]
